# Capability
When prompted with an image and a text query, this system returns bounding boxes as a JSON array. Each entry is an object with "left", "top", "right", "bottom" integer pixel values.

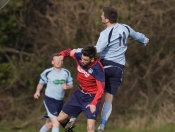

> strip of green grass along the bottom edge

[{"left": 0, "top": 123, "right": 175, "bottom": 132}]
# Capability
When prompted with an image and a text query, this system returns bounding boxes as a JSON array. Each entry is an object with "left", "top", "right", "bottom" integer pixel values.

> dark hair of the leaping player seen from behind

[{"left": 103, "top": 6, "right": 118, "bottom": 23}]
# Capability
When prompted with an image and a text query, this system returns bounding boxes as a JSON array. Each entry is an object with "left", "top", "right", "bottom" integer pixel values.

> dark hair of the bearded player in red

[{"left": 81, "top": 45, "right": 97, "bottom": 59}]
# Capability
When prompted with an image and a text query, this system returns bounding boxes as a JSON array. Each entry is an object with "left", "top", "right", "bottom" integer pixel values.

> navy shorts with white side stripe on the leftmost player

[{"left": 44, "top": 96, "right": 63, "bottom": 118}]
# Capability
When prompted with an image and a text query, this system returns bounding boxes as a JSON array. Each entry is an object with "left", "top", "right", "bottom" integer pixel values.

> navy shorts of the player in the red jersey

[{"left": 62, "top": 89, "right": 100, "bottom": 120}]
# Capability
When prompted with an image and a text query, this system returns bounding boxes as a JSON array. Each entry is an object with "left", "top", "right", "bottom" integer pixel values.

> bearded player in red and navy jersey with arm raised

[{"left": 57, "top": 46, "right": 105, "bottom": 132}]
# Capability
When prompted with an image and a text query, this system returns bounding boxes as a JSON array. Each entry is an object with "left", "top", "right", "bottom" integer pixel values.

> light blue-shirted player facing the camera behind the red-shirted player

[{"left": 34, "top": 53, "right": 73, "bottom": 132}]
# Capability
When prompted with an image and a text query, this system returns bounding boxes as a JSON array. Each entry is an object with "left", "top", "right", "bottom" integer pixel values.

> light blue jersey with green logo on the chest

[{"left": 39, "top": 67, "right": 73, "bottom": 100}]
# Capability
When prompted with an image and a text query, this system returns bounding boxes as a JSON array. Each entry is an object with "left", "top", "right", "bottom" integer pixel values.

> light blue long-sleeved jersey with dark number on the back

[{"left": 95, "top": 23, "right": 148, "bottom": 65}]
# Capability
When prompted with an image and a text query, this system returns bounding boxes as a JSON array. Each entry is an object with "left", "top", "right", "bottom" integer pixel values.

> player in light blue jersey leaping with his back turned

[{"left": 95, "top": 7, "right": 149, "bottom": 132}]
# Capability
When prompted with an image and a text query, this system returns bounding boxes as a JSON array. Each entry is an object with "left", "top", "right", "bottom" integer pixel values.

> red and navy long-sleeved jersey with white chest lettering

[{"left": 60, "top": 49, "right": 105, "bottom": 105}]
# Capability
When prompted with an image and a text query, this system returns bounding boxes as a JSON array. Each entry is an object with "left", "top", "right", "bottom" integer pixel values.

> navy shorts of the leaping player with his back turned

[{"left": 101, "top": 60, "right": 124, "bottom": 95}]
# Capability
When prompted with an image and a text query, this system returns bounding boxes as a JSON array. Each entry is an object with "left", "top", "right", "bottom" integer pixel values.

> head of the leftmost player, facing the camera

[{"left": 51, "top": 53, "right": 63, "bottom": 68}]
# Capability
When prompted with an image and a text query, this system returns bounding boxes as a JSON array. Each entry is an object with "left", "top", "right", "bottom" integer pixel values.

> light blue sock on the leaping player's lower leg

[{"left": 98, "top": 102, "right": 112, "bottom": 130}]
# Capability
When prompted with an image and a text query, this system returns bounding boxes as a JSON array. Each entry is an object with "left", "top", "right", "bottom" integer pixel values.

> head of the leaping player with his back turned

[{"left": 101, "top": 6, "right": 118, "bottom": 24}]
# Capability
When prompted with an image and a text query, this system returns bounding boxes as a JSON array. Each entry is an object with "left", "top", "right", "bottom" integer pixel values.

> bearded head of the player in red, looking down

[{"left": 81, "top": 46, "right": 97, "bottom": 66}]
